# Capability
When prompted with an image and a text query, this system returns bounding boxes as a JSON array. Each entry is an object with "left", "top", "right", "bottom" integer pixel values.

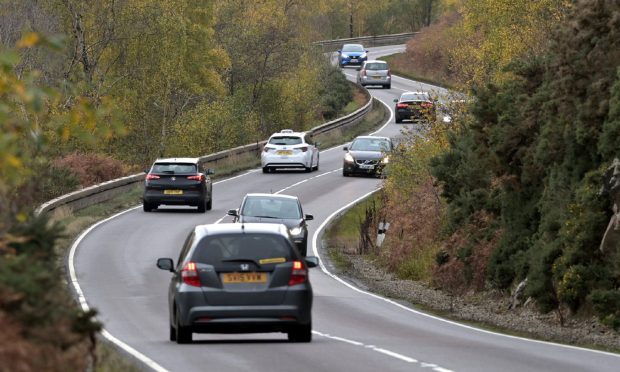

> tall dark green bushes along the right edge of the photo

[{"left": 432, "top": 0, "right": 620, "bottom": 326}]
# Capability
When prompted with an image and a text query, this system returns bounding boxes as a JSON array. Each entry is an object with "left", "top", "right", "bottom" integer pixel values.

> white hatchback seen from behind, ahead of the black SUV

[{"left": 260, "top": 129, "right": 319, "bottom": 173}]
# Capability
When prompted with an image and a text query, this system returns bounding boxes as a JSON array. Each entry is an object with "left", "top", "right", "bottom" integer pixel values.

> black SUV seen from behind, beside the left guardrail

[{"left": 142, "top": 158, "right": 213, "bottom": 213}]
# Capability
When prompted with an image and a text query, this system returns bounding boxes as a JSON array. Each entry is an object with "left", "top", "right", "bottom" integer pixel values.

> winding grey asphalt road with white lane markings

[{"left": 69, "top": 45, "right": 620, "bottom": 372}]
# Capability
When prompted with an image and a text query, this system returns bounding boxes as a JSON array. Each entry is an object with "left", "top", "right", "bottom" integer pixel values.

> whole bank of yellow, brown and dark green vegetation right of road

[{"left": 332, "top": 0, "right": 620, "bottom": 329}]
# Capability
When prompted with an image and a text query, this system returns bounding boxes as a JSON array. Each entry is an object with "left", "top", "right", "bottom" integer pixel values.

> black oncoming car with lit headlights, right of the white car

[{"left": 342, "top": 136, "right": 394, "bottom": 177}]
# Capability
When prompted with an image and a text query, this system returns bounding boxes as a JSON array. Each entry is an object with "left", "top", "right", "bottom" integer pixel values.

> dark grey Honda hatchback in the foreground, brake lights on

[{"left": 157, "top": 223, "right": 319, "bottom": 344}]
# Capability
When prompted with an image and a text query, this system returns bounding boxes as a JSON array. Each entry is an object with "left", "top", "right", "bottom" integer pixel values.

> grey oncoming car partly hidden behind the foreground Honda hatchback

[{"left": 228, "top": 193, "right": 314, "bottom": 257}]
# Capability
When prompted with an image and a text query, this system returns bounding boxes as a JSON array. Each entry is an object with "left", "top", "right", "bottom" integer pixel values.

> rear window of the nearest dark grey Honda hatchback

[{"left": 191, "top": 233, "right": 293, "bottom": 265}]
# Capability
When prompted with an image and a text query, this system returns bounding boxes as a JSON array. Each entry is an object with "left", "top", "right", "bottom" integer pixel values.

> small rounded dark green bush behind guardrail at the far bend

[{"left": 319, "top": 66, "right": 353, "bottom": 120}]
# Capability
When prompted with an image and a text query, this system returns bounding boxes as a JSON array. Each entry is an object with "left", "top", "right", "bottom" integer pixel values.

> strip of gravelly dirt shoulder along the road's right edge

[{"left": 328, "top": 250, "right": 620, "bottom": 353}]
